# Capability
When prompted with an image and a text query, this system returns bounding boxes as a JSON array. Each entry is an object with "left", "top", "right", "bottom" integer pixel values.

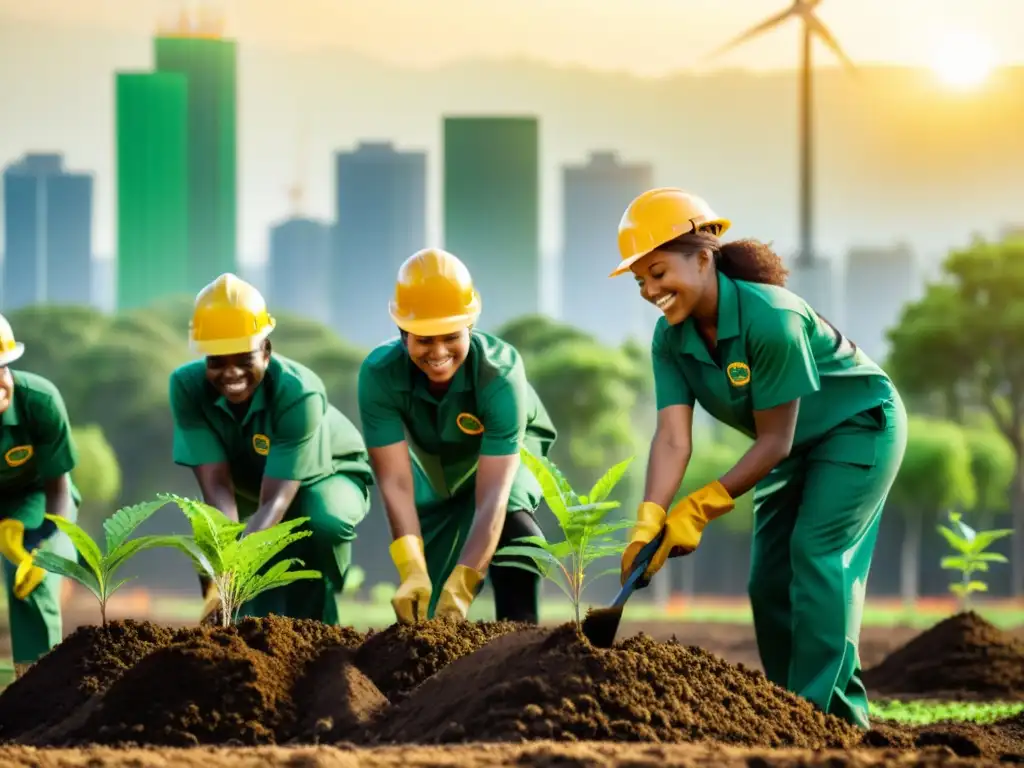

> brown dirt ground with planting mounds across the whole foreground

[{"left": 0, "top": 612, "right": 1024, "bottom": 768}]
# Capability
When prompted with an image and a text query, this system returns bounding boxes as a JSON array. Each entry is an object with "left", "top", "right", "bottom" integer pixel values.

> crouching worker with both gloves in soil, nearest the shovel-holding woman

[{"left": 358, "top": 249, "right": 557, "bottom": 624}]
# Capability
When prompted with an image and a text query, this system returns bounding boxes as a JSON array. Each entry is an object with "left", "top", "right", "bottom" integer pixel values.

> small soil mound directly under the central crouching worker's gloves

[{"left": 355, "top": 620, "right": 528, "bottom": 702}]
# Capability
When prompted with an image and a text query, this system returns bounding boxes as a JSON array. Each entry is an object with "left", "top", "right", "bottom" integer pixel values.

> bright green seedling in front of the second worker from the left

[{"left": 160, "top": 494, "right": 323, "bottom": 627}]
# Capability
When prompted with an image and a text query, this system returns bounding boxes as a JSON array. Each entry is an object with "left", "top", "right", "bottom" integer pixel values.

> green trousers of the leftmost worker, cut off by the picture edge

[{"left": 0, "top": 490, "right": 78, "bottom": 665}]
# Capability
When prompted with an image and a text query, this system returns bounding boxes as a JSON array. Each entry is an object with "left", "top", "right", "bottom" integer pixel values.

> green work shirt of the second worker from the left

[{"left": 170, "top": 354, "right": 373, "bottom": 502}]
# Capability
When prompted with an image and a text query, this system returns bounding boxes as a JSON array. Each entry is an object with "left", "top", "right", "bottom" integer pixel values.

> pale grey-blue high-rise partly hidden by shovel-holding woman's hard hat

[{"left": 558, "top": 152, "right": 659, "bottom": 344}]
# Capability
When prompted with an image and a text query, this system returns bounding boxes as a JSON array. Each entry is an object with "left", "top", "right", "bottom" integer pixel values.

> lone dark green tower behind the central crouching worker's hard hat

[{"left": 443, "top": 117, "right": 541, "bottom": 330}]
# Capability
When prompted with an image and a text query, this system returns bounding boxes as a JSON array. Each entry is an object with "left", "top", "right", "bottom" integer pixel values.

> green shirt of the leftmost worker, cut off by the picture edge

[{"left": 0, "top": 370, "right": 82, "bottom": 520}]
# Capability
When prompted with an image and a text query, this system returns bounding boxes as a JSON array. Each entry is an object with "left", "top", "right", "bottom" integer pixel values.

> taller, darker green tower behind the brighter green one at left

[{"left": 155, "top": 35, "right": 238, "bottom": 294}]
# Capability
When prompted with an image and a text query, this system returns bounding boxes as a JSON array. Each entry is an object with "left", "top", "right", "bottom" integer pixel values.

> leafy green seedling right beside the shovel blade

[{"left": 494, "top": 447, "right": 633, "bottom": 627}]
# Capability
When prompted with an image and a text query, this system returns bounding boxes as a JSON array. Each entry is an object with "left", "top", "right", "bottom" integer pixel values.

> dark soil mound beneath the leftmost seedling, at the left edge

[{"left": 0, "top": 618, "right": 174, "bottom": 740}]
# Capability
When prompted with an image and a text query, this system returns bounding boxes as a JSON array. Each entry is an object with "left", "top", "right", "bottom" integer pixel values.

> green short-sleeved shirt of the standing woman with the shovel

[{"left": 651, "top": 272, "right": 893, "bottom": 447}]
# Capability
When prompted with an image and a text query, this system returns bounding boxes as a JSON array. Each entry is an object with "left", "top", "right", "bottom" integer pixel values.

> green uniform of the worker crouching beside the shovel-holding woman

[{"left": 359, "top": 330, "right": 557, "bottom": 616}]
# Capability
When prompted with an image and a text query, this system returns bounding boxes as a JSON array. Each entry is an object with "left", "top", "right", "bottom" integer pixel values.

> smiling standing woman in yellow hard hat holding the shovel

[{"left": 611, "top": 188, "right": 906, "bottom": 727}]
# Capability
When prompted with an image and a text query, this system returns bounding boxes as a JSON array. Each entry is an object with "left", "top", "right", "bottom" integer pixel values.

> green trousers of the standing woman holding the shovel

[{"left": 749, "top": 390, "right": 907, "bottom": 728}]
